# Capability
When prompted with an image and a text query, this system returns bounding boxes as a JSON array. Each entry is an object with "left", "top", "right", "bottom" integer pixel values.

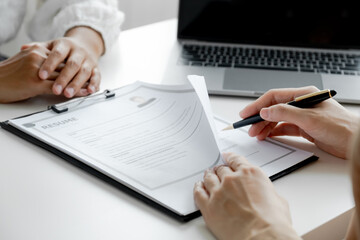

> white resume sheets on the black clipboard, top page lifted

[{"left": 3, "top": 80, "right": 312, "bottom": 218}]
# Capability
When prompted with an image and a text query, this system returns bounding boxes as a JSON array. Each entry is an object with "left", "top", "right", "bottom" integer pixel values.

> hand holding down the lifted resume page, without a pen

[{"left": 194, "top": 154, "right": 300, "bottom": 239}]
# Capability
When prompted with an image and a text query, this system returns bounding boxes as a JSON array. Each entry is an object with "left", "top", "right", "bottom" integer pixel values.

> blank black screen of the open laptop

[{"left": 178, "top": 0, "right": 360, "bottom": 49}]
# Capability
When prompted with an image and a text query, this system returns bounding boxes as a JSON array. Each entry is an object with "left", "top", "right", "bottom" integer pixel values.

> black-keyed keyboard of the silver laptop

[{"left": 178, "top": 44, "right": 360, "bottom": 75}]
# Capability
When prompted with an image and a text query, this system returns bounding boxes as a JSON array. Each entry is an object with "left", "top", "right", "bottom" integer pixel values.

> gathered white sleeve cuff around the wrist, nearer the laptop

[{"left": 28, "top": 0, "right": 125, "bottom": 52}]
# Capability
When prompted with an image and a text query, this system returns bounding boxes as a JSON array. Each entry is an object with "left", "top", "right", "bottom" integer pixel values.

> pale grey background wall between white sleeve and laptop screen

[{"left": 118, "top": 0, "right": 179, "bottom": 30}]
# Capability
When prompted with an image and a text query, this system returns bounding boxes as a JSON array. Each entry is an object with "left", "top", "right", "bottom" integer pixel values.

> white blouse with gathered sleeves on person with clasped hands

[{"left": 0, "top": 0, "right": 124, "bottom": 52}]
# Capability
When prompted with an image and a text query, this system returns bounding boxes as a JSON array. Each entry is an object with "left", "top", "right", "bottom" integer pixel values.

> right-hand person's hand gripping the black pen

[{"left": 226, "top": 87, "right": 359, "bottom": 158}]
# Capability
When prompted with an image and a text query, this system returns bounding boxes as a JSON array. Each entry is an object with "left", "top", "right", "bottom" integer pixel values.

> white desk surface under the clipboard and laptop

[{"left": 0, "top": 20, "right": 354, "bottom": 240}]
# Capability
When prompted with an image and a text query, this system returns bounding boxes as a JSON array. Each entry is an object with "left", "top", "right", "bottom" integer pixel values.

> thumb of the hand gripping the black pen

[{"left": 260, "top": 104, "right": 308, "bottom": 127}]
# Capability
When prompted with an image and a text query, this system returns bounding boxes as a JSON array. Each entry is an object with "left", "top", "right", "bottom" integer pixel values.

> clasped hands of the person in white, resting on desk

[{"left": 0, "top": 28, "right": 102, "bottom": 103}]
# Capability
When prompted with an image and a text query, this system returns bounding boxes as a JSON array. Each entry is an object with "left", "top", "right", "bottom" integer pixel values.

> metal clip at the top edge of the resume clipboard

[{"left": 48, "top": 90, "right": 115, "bottom": 113}]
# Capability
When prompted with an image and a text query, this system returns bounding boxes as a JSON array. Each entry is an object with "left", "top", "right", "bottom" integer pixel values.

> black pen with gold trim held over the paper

[{"left": 223, "top": 89, "right": 336, "bottom": 131}]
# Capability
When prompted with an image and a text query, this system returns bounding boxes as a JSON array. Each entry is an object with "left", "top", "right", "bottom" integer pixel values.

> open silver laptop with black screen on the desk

[{"left": 163, "top": 0, "right": 360, "bottom": 104}]
